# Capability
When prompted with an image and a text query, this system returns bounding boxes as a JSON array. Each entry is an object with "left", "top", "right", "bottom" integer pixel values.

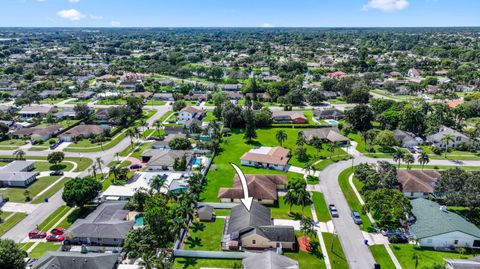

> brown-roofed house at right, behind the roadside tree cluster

[{"left": 397, "top": 170, "right": 440, "bottom": 198}]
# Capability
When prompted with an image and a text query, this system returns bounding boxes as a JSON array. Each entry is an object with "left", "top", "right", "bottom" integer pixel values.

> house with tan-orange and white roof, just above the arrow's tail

[{"left": 240, "top": 147, "right": 290, "bottom": 171}]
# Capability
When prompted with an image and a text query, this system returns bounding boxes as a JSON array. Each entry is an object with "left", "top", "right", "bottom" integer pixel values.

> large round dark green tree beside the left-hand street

[{"left": 62, "top": 177, "right": 102, "bottom": 207}]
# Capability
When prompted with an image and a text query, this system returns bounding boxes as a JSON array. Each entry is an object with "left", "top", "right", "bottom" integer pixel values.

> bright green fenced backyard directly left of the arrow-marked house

[{"left": 184, "top": 218, "right": 225, "bottom": 251}]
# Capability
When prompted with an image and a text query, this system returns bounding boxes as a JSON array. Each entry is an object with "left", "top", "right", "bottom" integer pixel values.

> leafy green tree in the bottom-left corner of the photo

[{"left": 0, "top": 239, "right": 27, "bottom": 269}]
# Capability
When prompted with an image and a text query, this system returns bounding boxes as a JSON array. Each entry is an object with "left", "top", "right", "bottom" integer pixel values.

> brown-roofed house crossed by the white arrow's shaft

[{"left": 218, "top": 174, "right": 287, "bottom": 204}]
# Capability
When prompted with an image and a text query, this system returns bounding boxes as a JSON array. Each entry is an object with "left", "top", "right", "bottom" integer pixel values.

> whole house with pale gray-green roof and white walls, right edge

[{"left": 409, "top": 198, "right": 480, "bottom": 248}]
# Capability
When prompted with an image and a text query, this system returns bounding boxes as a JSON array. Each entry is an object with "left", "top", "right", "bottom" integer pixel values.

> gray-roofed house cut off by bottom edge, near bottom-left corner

[{"left": 27, "top": 251, "right": 120, "bottom": 269}]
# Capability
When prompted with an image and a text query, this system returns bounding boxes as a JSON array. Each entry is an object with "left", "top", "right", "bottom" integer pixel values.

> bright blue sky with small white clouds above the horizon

[{"left": 0, "top": 0, "right": 480, "bottom": 27}]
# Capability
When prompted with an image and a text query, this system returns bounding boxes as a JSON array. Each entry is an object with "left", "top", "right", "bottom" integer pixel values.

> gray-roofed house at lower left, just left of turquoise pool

[{"left": 65, "top": 201, "right": 134, "bottom": 247}]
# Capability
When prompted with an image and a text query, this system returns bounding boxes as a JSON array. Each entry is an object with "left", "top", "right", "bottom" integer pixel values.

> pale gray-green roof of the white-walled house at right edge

[{"left": 410, "top": 198, "right": 480, "bottom": 239}]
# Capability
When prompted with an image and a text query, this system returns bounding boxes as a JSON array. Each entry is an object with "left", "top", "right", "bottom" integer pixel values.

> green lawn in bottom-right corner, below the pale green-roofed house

[{"left": 391, "top": 244, "right": 478, "bottom": 268}]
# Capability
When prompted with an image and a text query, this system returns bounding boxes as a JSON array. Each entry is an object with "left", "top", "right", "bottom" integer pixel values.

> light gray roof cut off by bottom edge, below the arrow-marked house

[{"left": 242, "top": 251, "right": 300, "bottom": 269}]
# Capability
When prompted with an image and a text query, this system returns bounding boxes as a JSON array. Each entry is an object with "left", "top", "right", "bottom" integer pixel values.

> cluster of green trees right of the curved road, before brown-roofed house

[{"left": 355, "top": 162, "right": 412, "bottom": 229}]
